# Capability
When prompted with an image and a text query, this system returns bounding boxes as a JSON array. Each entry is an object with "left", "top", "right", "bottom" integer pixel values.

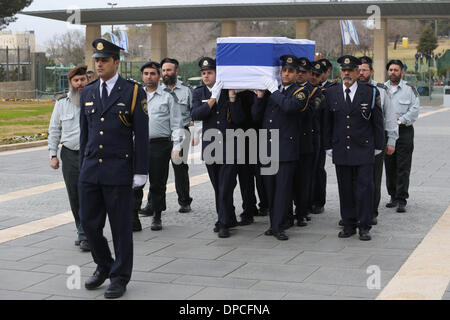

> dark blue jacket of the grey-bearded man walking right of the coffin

[{"left": 323, "top": 83, "right": 384, "bottom": 166}]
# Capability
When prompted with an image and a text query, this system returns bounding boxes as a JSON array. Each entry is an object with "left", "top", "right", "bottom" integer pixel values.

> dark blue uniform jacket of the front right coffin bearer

[{"left": 252, "top": 84, "right": 313, "bottom": 162}]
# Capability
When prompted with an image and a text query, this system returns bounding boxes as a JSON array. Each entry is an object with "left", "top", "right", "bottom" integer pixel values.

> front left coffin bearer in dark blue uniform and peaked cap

[{"left": 191, "top": 57, "right": 245, "bottom": 238}]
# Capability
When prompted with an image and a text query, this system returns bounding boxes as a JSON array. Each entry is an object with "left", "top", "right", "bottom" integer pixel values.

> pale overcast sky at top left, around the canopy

[{"left": 7, "top": 0, "right": 320, "bottom": 46}]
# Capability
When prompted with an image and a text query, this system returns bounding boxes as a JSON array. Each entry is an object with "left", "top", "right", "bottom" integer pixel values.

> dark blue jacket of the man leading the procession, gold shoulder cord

[{"left": 79, "top": 76, "right": 149, "bottom": 185}]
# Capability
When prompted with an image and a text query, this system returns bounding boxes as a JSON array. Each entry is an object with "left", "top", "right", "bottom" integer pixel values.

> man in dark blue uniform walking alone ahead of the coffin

[{"left": 79, "top": 39, "right": 148, "bottom": 298}]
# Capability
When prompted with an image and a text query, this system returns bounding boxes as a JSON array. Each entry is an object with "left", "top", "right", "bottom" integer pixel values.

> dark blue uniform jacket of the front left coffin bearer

[{"left": 191, "top": 86, "right": 245, "bottom": 164}]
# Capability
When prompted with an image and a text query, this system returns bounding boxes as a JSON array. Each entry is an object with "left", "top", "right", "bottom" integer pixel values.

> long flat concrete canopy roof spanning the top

[{"left": 20, "top": 0, "right": 450, "bottom": 25}]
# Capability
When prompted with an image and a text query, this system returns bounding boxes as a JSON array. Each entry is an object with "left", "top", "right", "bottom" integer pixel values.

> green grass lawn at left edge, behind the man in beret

[{"left": 0, "top": 102, "right": 54, "bottom": 140}]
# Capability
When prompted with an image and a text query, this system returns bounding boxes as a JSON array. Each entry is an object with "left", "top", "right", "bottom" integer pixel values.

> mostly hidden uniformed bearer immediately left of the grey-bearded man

[{"left": 311, "top": 59, "right": 334, "bottom": 214}]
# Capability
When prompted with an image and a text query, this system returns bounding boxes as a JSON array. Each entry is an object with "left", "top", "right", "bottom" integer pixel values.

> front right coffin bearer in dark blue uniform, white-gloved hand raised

[{"left": 252, "top": 55, "right": 310, "bottom": 240}]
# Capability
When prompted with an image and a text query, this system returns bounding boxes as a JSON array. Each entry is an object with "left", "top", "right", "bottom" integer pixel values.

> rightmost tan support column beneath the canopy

[{"left": 373, "top": 19, "right": 388, "bottom": 83}]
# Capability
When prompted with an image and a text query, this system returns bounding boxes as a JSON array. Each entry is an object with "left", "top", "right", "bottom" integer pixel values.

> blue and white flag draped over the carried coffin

[{"left": 216, "top": 37, "right": 315, "bottom": 89}]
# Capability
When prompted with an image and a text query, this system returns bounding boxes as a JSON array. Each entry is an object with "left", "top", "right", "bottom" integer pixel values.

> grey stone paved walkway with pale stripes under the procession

[{"left": 0, "top": 107, "right": 450, "bottom": 300}]
